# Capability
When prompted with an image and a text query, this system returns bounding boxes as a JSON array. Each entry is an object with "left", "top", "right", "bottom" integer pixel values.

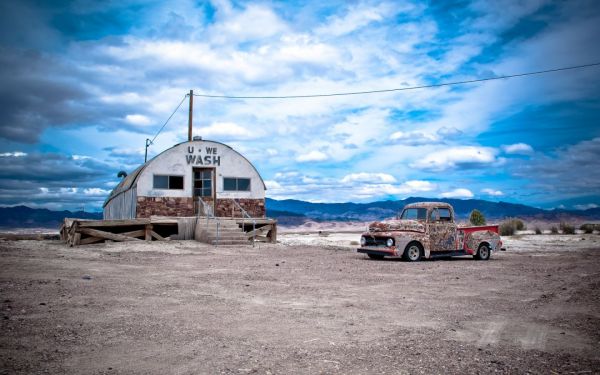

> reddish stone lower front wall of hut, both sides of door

[{"left": 136, "top": 197, "right": 266, "bottom": 218}]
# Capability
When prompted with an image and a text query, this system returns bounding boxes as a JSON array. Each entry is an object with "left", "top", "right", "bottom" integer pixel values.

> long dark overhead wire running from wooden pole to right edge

[{"left": 194, "top": 62, "right": 600, "bottom": 99}]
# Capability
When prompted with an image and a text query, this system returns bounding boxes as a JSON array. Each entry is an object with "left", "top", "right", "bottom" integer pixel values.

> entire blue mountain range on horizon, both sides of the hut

[{"left": 0, "top": 197, "right": 600, "bottom": 228}]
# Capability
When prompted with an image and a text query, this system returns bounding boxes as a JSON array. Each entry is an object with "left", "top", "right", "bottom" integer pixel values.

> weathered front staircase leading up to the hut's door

[{"left": 195, "top": 217, "right": 249, "bottom": 245}]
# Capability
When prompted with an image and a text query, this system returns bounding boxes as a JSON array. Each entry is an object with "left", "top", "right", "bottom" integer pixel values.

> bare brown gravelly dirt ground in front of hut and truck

[{"left": 0, "top": 233, "right": 600, "bottom": 374}]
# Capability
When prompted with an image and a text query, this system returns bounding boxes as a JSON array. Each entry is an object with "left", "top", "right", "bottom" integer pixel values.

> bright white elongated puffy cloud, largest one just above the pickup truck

[{"left": 411, "top": 146, "right": 501, "bottom": 171}]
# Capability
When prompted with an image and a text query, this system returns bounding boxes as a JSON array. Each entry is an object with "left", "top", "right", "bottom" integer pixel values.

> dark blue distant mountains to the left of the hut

[{"left": 0, "top": 206, "right": 102, "bottom": 229}]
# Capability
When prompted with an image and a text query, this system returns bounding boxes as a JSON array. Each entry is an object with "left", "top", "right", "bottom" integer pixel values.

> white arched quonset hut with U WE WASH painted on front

[{"left": 104, "top": 137, "right": 266, "bottom": 220}]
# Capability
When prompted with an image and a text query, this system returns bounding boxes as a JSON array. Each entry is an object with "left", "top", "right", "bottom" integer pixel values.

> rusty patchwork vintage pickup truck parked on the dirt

[{"left": 358, "top": 202, "right": 505, "bottom": 262}]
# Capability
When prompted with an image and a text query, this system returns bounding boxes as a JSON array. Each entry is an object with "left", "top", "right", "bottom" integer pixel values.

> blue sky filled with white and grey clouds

[{"left": 0, "top": 0, "right": 600, "bottom": 211}]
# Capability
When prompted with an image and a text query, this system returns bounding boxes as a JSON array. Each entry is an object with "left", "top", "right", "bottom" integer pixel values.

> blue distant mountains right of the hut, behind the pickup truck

[{"left": 266, "top": 197, "right": 600, "bottom": 221}]
